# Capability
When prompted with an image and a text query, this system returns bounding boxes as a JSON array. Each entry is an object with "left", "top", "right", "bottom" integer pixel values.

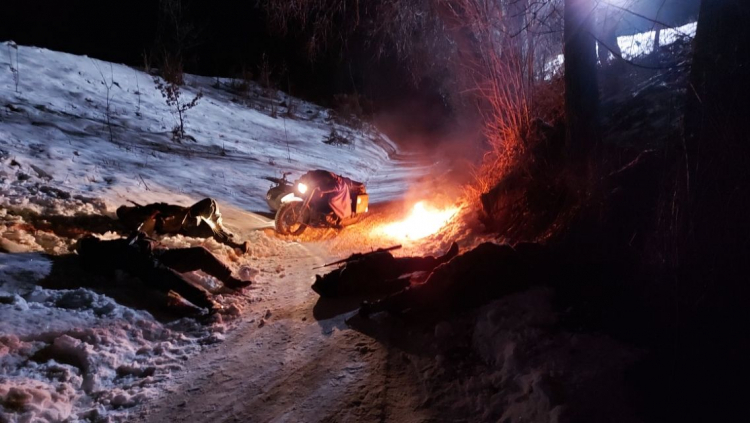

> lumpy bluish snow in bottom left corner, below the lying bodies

[{"left": 0, "top": 253, "right": 221, "bottom": 422}]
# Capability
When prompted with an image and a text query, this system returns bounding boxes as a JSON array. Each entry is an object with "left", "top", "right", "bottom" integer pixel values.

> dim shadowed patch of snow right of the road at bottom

[{"left": 464, "top": 289, "right": 641, "bottom": 422}]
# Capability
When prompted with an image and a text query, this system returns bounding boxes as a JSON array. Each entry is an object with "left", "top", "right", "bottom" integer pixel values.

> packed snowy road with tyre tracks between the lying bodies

[{"left": 135, "top": 210, "right": 434, "bottom": 422}]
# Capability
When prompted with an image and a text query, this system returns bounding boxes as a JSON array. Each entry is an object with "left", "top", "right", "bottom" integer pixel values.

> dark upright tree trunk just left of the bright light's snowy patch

[{"left": 563, "top": 0, "right": 600, "bottom": 177}]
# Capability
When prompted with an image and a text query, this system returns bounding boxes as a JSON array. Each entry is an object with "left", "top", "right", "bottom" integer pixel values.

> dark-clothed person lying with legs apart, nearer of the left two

[{"left": 76, "top": 232, "right": 252, "bottom": 312}]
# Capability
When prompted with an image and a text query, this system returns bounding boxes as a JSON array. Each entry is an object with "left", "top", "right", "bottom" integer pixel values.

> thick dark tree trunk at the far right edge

[{"left": 685, "top": 0, "right": 750, "bottom": 304}]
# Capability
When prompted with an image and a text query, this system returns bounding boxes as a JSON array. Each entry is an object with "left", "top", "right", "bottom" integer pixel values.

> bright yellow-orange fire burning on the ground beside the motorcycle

[{"left": 379, "top": 201, "right": 459, "bottom": 240}]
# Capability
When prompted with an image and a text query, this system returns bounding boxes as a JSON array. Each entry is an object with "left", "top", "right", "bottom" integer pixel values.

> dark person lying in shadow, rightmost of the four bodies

[{"left": 359, "top": 242, "right": 552, "bottom": 318}]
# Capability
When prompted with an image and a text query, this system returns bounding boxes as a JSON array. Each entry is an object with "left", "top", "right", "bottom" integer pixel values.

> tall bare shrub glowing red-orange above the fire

[{"left": 441, "top": 0, "right": 559, "bottom": 205}]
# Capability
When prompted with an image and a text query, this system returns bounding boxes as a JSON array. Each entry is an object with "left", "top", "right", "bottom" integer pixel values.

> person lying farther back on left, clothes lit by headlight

[{"left": 117, "top": 198, "right": 250, "bottom": 253}]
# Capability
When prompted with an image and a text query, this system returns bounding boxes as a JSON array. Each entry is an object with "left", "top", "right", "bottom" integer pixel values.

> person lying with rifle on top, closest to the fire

[{"left": 312, "top": 242, "right": 458, "bottom": 297}]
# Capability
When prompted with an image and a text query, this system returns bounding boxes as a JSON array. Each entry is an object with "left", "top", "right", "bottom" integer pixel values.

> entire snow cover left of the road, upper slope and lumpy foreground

[{"left": 0, "top": 42, "right": 426, "bottom": 421}]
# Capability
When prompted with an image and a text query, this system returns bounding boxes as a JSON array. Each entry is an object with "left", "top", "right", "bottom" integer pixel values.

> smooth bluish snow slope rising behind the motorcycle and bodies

[{"left": 0, "top": 43, "right": 424, "bottom": 210}]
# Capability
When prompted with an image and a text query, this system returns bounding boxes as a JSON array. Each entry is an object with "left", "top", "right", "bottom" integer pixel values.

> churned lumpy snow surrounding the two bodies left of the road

[{"left": 0, "top": 141, "right": 285, "bottom": 422}]
